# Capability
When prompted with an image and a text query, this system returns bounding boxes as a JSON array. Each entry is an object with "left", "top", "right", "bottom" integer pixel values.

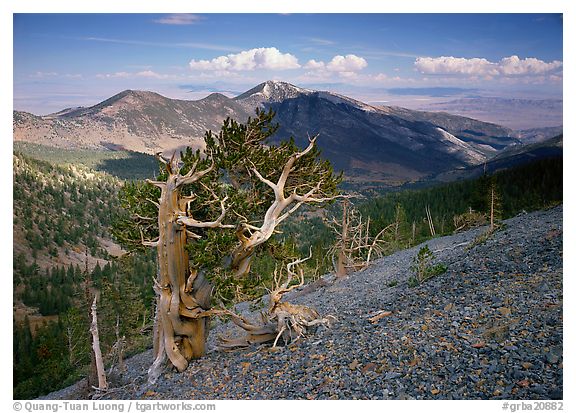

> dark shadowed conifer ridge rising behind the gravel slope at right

[{"left": 361, "top": 157, "right": 563, "bottom": 235}]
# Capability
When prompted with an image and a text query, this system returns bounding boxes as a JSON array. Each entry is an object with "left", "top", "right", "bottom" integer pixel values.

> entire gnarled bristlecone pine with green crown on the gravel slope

[{"left": 113, "top": 111, "right": 341, "bottom": 382}]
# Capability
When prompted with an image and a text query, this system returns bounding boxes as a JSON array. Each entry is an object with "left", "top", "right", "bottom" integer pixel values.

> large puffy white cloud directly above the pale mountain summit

[{"left": 189, "top": 47, "right": 301, "bottom": 71}]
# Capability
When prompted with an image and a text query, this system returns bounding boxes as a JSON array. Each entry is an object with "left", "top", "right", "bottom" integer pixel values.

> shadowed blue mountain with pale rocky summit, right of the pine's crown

[{"left": 235, "top": 81, "right": 517, "bottom": 184}]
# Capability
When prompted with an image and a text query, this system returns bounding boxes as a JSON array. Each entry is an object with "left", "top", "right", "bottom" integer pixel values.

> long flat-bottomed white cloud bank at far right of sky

[{"left": 414, "top": 56, "right": 562, "bottom": 77}]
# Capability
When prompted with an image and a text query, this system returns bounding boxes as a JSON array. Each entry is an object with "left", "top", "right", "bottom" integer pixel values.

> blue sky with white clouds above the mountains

[{"left": 13, "top": 13, "right": 563, "bottom": 114}]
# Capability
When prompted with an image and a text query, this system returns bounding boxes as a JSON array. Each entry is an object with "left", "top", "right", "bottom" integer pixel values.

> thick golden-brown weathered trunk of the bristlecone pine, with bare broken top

[{"left": 143, "top": 158, "right": 225, "bottom": 382}]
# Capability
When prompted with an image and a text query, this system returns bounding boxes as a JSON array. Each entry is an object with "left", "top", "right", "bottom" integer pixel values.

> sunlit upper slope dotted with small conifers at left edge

[{"left": 13, "top": 154, "right": 120, "bottom": 267}]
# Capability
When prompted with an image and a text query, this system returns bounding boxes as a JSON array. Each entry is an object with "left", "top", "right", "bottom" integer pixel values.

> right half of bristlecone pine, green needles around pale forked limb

[{"left": 205, "top": 111, "right": 342, "bottom": 278}]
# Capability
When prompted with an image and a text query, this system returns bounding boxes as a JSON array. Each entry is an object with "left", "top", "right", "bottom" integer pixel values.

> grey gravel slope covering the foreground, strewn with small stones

[{"left": 48, "top": 206, "right": 563, "bottom": 399}]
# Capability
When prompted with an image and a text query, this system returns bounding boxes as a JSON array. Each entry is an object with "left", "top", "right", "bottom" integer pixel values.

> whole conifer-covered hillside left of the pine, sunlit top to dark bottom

[{"left": 13, "top": 153, "right": 156, "bottom": 398}]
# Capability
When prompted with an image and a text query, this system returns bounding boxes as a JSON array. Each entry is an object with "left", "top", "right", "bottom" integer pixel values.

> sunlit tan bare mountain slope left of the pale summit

[{"left": 14, "top": 90, "right": 248, "bottom": 153}]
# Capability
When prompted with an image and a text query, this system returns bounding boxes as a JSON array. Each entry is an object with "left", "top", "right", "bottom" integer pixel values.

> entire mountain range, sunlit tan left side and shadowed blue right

[{"left": 13, "top": 81, "right": 552, "bottom": 185}]
